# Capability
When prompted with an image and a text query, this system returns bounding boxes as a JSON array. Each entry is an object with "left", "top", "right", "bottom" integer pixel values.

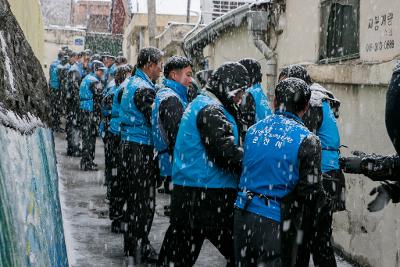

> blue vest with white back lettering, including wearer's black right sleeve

[{"left": 236, "top": 112, "right": 320, "bottom": 222}]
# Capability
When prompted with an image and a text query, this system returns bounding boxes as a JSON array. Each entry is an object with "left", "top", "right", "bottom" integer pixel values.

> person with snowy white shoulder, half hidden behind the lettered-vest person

[{"left": 279, "top": 65, "right": 345, "bottom": 267}]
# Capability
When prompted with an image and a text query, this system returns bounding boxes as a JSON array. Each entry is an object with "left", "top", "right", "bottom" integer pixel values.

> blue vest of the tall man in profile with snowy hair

[{"left": 119, "top": 69, "right": 155, "bottom": 145}]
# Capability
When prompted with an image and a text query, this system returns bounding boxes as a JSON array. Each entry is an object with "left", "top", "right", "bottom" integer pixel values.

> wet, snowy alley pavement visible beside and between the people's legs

[{"left": 55, "top": 134, "right": 352, "bottom": 267}]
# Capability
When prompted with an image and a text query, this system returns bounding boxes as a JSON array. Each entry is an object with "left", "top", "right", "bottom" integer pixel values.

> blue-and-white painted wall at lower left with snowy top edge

[{"left": 0, "top": 110, "right": 68, "bottom": 267}]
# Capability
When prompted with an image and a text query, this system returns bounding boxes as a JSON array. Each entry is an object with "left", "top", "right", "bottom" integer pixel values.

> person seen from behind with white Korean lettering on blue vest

[{"left": 234, "top": 78, "right": 322, "bottom": 266}]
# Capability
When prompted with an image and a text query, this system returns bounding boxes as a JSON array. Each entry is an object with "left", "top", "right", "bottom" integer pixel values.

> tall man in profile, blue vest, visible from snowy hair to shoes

[{"left": 120, "top": 47, "right": 163, "bottom": 263}]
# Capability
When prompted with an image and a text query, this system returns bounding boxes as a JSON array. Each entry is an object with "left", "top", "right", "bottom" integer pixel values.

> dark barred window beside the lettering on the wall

[{"left": 320, "top": 0, "right": 360, "bottom": 63}]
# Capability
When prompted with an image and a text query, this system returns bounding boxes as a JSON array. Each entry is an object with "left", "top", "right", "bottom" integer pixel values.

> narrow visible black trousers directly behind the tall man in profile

[{"left": 106, "top": 133, "right": 125, "bottom": 220}]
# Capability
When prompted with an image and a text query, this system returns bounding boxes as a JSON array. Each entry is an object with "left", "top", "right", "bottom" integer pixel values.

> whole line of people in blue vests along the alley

[{"left": 49, "top": 44, "right": 390, "bottom": 267}]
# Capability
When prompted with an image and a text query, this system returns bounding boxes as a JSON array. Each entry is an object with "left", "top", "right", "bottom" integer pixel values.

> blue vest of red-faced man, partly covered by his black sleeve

[{"left": 151, "top": 79, "right": 188, "bottom": 177}]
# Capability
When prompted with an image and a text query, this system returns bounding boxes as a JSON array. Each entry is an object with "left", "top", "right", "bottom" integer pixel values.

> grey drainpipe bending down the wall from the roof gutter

[{"left": 247, "top": 11, "right": 277, "bottom": 94}]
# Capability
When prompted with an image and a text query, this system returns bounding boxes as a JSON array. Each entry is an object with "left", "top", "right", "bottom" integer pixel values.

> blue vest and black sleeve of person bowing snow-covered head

[{"left": 172, "top": 91, "right": 242, "bottom": 189}]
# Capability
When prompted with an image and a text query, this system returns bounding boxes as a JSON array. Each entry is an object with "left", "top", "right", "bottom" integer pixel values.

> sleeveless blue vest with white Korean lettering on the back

[{"left": 235, "top": 112, "right": 311, "bottom": 222}]
